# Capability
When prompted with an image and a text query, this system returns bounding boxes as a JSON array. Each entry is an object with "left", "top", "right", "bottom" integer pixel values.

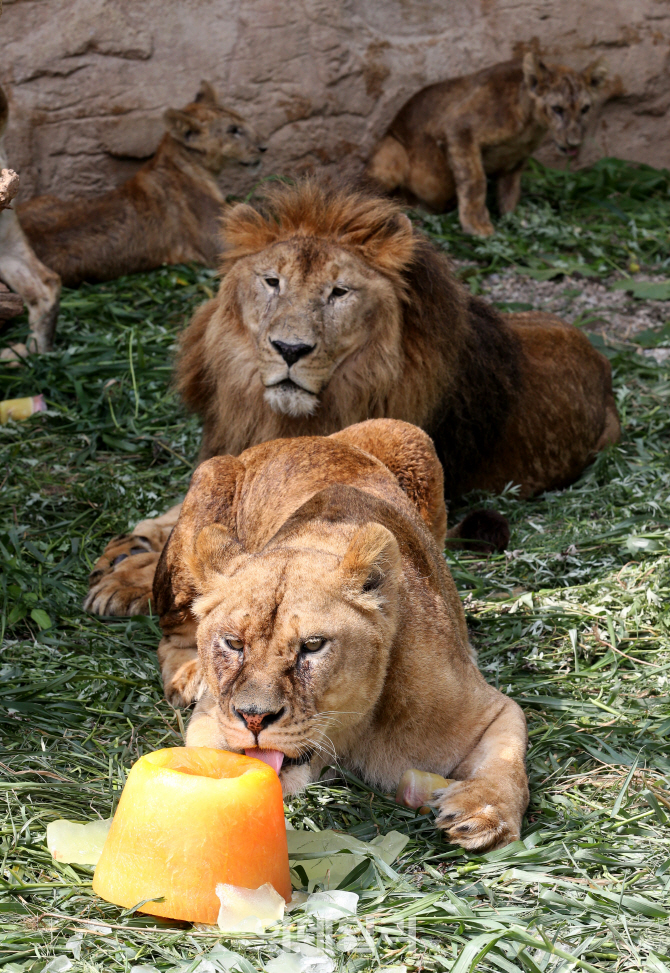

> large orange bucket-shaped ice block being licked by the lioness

[{"left": 93, "top": 747, "right": 291, "bottom": 925}]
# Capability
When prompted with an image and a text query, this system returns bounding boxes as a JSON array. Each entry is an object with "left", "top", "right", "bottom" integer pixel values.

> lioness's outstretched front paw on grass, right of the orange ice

[{"left": 430, "top": 780, "right": 525, "bottom": 851}]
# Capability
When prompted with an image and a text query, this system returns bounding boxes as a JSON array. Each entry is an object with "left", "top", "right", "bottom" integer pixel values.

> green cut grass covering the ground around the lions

[{"left": 0, "top": 163, "right": 670, "bottom": 973}]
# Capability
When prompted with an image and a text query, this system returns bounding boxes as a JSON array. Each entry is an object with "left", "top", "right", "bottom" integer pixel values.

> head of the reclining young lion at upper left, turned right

[{"left": 163, "top": 81, "right": 265, "bottom": 174}]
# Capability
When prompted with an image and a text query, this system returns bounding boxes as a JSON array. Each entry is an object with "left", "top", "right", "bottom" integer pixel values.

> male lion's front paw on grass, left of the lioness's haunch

[{"left": 84, "top": 534, "right": 160, "bottom": 615}]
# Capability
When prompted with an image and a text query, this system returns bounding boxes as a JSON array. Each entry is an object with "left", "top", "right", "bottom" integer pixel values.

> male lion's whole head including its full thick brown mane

[{"left": 177, "top": 179, "right": 466, "bottom": 457}]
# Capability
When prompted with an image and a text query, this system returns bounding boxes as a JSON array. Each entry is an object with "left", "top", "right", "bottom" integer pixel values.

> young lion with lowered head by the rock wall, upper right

[{"left": 366, "top": 52, "right": 607, "bottom": 236}]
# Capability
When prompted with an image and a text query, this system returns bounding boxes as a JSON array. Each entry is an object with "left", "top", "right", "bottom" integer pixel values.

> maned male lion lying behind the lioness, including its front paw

[{"left": 85, "top": 180, "right": 619, "bottom": 615}]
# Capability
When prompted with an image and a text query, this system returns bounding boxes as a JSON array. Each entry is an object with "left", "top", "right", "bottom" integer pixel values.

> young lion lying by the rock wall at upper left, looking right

[{"left": 17, "top": 81, "right": 265, "bottom": 287}]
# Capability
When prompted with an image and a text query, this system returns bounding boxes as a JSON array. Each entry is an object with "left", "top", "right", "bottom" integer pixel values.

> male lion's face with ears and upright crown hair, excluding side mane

[{"left": 223, "top": 183, "right": 413, "bottom": 416}]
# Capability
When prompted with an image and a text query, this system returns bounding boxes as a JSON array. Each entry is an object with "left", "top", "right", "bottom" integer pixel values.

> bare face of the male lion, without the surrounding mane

[{"left": 232, "top": 237, "right": 400, "bottom": 416}]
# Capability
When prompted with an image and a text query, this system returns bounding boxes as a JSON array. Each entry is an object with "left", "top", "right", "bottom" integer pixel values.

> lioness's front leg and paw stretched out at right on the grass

[{"left": 431, "top": 699, "right": 528, "bottom": 851}]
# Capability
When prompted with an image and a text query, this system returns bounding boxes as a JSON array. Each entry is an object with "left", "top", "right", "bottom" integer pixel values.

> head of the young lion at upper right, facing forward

[{"left": 523, "top": 51, "right": 608, "bottom": 155}]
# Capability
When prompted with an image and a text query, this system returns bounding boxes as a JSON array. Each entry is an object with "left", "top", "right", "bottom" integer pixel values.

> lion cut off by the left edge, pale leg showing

[{"left": 0, "top": 87, "right": 61, "bottom": 359}]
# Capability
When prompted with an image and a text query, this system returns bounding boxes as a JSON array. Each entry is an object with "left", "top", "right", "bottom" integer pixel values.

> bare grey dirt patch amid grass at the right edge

[{"left": 482, "top": 270, "right": 670, "bottom": 363}]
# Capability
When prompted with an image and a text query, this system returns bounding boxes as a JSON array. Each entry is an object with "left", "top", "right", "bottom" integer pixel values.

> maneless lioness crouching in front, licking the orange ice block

[{"left": 154, "top": 419, "right": 528, "bottom": 849}]
